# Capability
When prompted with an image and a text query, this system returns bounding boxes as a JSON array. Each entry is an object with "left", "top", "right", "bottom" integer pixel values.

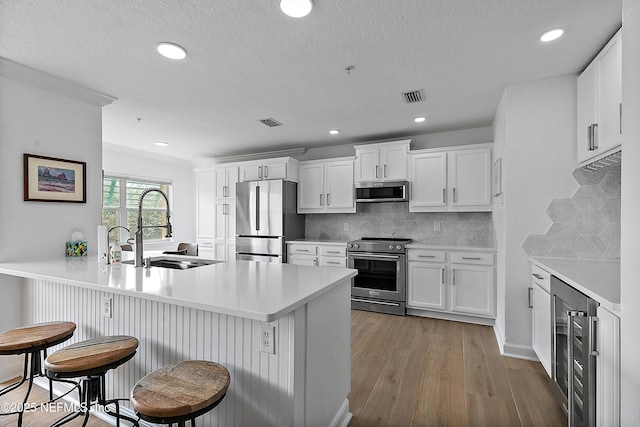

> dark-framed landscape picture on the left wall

[{"left": 23, "top": 153, "right": 87, "bottom": 203}]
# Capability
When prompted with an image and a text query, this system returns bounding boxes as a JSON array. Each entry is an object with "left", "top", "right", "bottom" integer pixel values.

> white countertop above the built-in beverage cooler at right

[{"left": 531, "top": 257, "right": 620, "bottom": 312}]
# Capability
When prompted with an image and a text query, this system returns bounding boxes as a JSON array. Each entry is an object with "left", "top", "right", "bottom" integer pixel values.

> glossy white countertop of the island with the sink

[{"left": 0, "top": 257, "right": 357, "bottom": 321}]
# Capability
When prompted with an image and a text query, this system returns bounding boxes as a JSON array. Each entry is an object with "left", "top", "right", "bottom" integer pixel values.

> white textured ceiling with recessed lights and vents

[{"left": 0, "top": 0, "right": 621, "bottom": 159}]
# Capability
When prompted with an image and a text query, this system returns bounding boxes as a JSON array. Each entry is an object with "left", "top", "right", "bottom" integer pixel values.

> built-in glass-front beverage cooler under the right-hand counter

[{"left": 551, "top": 276, "right": 598, "bottom": 427}]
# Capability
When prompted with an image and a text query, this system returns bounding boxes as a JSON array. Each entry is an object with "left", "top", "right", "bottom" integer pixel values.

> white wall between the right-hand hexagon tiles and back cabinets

[{"left": 494, "top": 75, "right": 577, "bottom": 356}]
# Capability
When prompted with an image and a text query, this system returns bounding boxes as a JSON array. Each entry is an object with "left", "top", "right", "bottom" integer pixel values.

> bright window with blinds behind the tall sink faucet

[{"left": 102, "top": 176, "right": 171, "bottom": 242}]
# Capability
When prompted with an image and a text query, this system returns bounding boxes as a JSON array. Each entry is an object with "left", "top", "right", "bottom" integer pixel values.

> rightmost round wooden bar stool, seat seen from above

[{"left": 130, "top": 360, "right": 231, "bottom": 427}]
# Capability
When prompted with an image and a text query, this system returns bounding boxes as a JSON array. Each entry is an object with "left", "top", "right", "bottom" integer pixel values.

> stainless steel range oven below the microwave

[{"left": 347, "top": 237, "right": 411, "bottom": 316}]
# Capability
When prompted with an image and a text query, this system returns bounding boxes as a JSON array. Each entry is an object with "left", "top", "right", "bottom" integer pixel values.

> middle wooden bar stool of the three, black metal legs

[{"left": 44, "top": 335, "right": 138, "bottom": 427}]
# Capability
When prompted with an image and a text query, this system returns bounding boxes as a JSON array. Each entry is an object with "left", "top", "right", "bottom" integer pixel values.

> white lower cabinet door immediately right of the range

[{"left": 407, "top": 262, "right": 447, "bottom": 310}]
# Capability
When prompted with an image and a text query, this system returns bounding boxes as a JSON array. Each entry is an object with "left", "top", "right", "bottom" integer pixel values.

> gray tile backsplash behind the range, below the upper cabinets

[{"left": 305, "top": 202, "right": 493, "bottom": 246}]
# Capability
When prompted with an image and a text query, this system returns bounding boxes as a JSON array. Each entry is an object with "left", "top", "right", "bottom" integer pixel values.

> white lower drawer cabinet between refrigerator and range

[{"left": 287, "top": 241, "right": 347, "bottom": 267}]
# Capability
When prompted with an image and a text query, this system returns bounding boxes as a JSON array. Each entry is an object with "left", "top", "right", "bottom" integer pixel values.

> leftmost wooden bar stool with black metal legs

[{"left": 0, "top": 322, "right": 76, "bottom": 426}]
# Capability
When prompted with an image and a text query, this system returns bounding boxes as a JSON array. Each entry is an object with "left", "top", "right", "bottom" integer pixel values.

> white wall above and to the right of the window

[{"left": 102, "top": 144, "right": 196, "bottom": 249}]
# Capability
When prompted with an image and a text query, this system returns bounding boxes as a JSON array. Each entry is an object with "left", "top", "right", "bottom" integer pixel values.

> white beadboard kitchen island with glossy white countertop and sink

[{"left": 0, "top": 258, "right": 356, "bottom": 427}]
